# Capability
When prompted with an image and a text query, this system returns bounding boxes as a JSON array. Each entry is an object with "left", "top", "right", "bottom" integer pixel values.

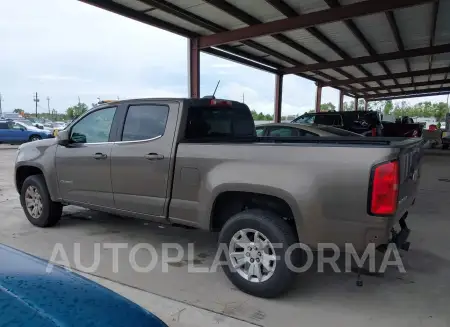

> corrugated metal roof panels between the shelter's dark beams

[{"left": 82, "top": 0, "right": 450, "bottom": 100}]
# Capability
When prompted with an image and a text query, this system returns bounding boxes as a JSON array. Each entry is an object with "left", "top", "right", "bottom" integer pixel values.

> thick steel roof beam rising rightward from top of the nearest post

[{"left": 199, "top": 0, "right": 433, "bottom": 48}]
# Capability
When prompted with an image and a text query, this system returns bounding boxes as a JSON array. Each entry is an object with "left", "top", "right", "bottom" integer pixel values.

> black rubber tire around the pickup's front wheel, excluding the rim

[{"left": 20, "top": 175, "right": 62, "bottom": 227}]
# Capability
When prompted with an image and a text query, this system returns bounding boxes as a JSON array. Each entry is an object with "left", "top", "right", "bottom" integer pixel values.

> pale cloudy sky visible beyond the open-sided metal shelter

[{"left": 0, "top": 0, "right": 446, "bottom": 115}]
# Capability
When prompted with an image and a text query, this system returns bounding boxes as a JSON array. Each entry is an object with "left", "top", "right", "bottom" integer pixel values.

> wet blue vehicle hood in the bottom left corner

[{"left": 0, "top": 244, "right": 167, "bottom": 327}]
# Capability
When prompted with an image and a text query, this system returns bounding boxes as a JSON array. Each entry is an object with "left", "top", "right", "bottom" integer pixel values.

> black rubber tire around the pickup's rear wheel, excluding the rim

[{"left": 219, "top": 209, "right": 298, "bottom": 298}]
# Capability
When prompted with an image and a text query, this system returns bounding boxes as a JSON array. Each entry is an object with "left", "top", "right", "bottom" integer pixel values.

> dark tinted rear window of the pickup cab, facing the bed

[{"left": 186, "top": 106, "right": 256, "bottom": 139}]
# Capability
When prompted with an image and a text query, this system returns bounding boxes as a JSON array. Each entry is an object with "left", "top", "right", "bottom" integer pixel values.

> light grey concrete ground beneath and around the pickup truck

[{"left": 0, "top": 149, "right": 450, "bottom": 327}]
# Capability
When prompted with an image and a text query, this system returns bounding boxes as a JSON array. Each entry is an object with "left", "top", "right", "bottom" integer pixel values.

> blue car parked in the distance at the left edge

[{"left": 0, "top": 120, "right": 53, "bottom": 144}]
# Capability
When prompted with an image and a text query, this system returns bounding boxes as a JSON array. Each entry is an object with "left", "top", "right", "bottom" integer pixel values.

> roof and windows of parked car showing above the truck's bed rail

[{"left": 256, "top": 123, "right": 362, "bottom": 137}]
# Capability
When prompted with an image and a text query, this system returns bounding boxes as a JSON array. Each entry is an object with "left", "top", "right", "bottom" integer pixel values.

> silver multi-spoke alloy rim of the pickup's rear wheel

[{"left": 228, "top": 228, "right": 276, "bottom": 283}]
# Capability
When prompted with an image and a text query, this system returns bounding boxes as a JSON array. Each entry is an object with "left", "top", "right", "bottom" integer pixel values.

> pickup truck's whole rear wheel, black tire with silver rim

[{"left": 219, "top": 209, "right": 297, "bottom": 298}]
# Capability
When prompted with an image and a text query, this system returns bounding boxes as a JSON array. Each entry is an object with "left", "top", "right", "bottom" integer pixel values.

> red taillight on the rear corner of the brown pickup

[{"left": 370, "top": 161, "right": 399, "bottom": 216}]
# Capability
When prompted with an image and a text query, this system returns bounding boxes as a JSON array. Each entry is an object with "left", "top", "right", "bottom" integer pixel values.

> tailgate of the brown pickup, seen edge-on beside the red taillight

[{"left": 398, "top": 142, "right": 423, "bottom": 212}]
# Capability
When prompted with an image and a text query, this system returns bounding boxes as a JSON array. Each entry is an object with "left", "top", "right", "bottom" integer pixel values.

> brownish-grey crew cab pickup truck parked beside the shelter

[{"left": 15, "top": 98, "right": 422, "bottom": 297}]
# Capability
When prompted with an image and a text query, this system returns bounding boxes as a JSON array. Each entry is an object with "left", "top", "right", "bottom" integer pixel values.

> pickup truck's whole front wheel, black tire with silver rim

[{"left": 20, "top": 175, "right": 62, "bottom": 227}]
